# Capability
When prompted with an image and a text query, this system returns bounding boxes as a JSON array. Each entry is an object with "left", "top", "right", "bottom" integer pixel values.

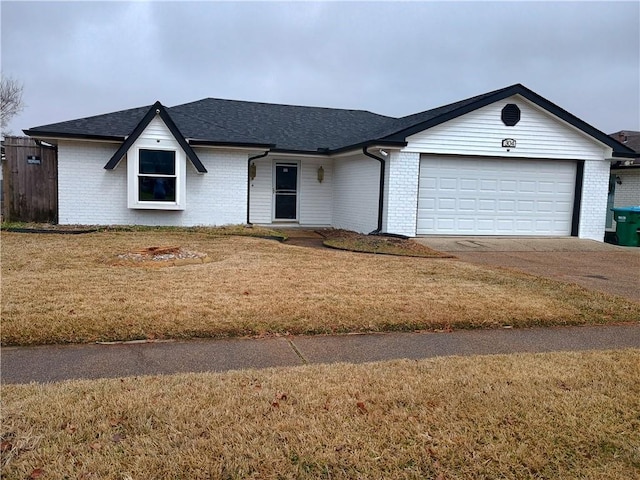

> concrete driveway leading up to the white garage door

[{"left": 416, "top": 237, "right": 640, "bottom": 302}]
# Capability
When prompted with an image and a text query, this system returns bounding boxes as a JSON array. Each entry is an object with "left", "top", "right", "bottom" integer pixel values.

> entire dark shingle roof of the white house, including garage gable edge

[{"left": 24, "top": 84, "right": 633, "bottom": 156}]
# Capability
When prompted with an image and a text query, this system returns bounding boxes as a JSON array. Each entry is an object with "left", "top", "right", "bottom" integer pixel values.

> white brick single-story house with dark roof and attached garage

[{"left": 25, "top": 84, "right": 634, "bottom": 241}]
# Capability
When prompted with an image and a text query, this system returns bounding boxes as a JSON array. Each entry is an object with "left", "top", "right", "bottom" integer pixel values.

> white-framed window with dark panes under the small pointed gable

[{"left": 127, "top": 145, "right": 186, "bottom": 210}]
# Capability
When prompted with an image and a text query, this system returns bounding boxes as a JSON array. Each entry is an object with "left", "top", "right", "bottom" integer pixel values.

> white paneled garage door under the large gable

[{"left": 417, "top": 157, "right": 576, "bottom": 236}]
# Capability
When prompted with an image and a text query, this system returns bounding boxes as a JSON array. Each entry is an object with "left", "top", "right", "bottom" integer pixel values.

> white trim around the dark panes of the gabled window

[{"left": 127, "top": 142, "right": 187, "bottom": 210}]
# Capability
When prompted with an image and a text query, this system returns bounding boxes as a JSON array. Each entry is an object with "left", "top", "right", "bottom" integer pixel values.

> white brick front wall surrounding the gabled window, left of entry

[{"left": 58, "top": 141, "right": 247, "bottom": 226}]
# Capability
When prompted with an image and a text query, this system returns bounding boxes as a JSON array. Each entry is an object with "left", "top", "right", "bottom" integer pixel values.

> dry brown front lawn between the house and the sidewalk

[{"left": 1, "top": 231, "right": 638, "bottom": 345}]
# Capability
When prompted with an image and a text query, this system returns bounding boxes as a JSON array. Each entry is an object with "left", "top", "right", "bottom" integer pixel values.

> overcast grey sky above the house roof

[{"left": 0, "top": 0, "right": 640, "bottom": 134}]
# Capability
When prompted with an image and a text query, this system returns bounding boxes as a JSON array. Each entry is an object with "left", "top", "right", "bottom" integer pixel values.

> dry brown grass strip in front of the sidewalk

[{"left": 2, "top": 350, "right": 640, "bottom": 480}]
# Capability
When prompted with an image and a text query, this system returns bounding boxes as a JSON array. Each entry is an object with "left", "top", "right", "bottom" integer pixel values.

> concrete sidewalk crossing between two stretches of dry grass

[{"left": 0, "top": 323, "right": 640, "bottom": 383}]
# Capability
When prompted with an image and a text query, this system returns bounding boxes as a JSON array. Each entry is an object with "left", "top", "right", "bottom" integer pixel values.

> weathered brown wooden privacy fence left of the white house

[{"left": 2, "top": 137, "right": 58, "bottom": 223}]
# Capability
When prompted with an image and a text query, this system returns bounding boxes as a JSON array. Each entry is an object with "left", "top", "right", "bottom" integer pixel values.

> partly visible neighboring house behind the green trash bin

[{"left": 606, "top": 130, "right": 640, "bottom": 231}]
